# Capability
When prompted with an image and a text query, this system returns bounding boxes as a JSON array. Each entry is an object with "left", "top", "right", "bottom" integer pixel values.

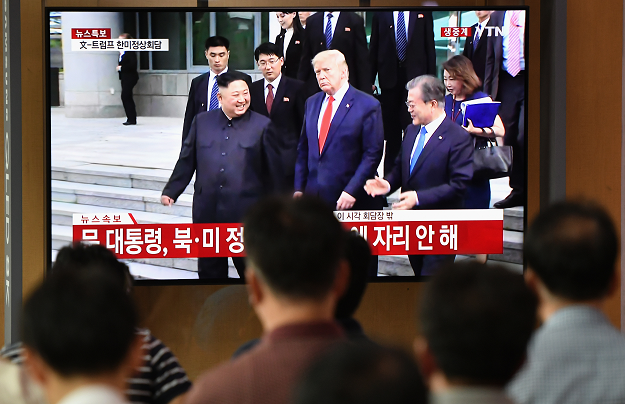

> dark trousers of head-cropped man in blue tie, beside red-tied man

[{"left": 379, "top": 63, "right": 413, "bottom": 175}]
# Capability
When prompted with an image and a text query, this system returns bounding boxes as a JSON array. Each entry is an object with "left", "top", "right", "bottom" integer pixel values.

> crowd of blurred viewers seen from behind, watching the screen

[{"left": 0, "top": 197, "right": 625, "bottom": 404}]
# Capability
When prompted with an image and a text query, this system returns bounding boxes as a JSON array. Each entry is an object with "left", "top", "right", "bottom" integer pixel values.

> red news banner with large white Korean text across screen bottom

[{"left": 73, "top": 209, "right": 503, "bottom": 259}]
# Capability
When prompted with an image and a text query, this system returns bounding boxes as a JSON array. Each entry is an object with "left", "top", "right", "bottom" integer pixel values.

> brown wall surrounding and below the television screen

[{"left": 0, "top": 0, "right": 622, "bottom": 378}]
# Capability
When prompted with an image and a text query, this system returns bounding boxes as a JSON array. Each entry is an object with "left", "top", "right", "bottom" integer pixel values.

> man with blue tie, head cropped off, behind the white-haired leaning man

[{"left": 369, "top": 11, "right": 436, "bottom": 173}]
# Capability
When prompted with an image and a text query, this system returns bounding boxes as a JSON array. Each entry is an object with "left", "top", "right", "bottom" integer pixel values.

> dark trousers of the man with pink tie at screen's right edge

[{"left": 497, "top": 68, "right": 525, "bottom": 197}]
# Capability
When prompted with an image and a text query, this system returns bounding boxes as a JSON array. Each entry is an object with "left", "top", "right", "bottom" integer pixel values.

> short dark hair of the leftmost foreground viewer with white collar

[{"left": 23, "top": 271, "right": 137, "bottom": 377}]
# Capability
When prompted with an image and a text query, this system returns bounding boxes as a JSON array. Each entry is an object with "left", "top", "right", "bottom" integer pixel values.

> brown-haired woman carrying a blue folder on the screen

[{"left": 443, "top": 55, "right": 505, "bottom": 262}]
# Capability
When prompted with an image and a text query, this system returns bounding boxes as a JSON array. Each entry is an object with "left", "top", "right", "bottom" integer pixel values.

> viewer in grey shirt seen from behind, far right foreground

[{"left": 507, "top": 202, "right": 625, "bottom": 404}]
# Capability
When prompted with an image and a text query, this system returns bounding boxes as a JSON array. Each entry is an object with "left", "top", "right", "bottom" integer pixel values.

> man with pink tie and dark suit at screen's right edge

[{"left": 484, "top": 10, "right": 526, "bottom": 209}]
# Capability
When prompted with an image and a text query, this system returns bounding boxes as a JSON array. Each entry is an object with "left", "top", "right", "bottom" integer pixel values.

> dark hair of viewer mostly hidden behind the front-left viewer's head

[{"left": 50, "top": 243, "right": 133, "bottom": 293}]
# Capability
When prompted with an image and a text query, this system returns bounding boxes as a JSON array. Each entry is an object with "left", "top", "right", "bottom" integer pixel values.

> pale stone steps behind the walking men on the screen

[{"left": 51, "top": 164, "right": 523, "bottom": 279}]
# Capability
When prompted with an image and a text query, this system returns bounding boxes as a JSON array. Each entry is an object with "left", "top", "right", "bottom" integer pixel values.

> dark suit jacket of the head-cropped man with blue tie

[{"left": 369, "top": 11, "right": 436, "bottom": 89}]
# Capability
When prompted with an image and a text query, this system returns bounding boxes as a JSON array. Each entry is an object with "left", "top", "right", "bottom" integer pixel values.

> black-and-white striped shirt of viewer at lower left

[{"left": 0, "top": 329, "right": 191, "bottom": 404}]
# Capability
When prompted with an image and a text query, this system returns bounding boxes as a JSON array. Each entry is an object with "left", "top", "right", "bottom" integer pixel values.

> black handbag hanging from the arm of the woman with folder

[{"left": 473, "top": 138, "right": 512, "bottom": 179}]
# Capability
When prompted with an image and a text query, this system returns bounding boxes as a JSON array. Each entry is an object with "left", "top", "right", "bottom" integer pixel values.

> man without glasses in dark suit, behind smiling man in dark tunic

[{"left": 182, "top": 36, "right": 252, "bottom": 143}]
